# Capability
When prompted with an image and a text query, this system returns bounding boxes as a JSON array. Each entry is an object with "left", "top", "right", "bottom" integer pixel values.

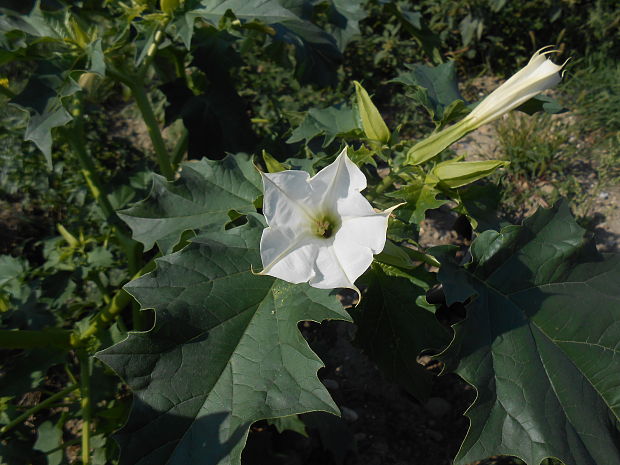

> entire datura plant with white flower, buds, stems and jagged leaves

[{"left": 0, "top": 0, "right": 620, "bottom": 465}]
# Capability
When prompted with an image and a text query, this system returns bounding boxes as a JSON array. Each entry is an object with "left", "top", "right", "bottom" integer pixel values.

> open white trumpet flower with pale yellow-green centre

[{"left": 259, "top": 148, "right": 398, "bottom": 294}]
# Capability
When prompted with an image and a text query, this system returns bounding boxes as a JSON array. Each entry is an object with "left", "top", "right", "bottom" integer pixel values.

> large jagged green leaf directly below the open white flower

[{"left": 97, "top": 215, "right": 349, "bottom": 465}]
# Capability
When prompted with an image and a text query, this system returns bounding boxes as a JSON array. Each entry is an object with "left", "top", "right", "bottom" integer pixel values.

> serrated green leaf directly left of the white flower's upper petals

[{"left": 118, "top": 154, "right": 262, "bottom": 252}]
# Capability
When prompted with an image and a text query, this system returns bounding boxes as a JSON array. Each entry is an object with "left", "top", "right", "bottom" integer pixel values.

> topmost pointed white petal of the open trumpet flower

[{"left": 310, "top": 147, "right": 366, "bottom": 211}]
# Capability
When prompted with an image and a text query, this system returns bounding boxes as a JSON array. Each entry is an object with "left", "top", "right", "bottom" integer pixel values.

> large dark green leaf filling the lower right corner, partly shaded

[{"left": 439, "top": 203, "right": 620, "bottom": 465}]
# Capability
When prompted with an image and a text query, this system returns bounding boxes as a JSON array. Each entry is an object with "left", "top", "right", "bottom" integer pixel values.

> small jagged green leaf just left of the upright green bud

[{"left": 286, "top": 105, "right": 362, "bottom": 147}]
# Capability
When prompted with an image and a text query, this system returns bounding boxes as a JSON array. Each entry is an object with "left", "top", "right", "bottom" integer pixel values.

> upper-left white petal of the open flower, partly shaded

[{"left": 262, "top": 170, "right": 312, "bottom": 232}]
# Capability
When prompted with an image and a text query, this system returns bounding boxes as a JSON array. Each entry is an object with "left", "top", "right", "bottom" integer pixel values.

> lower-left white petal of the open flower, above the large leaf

[{"left": 258, "top": 227, "right": 321, "bottom": 284}]
